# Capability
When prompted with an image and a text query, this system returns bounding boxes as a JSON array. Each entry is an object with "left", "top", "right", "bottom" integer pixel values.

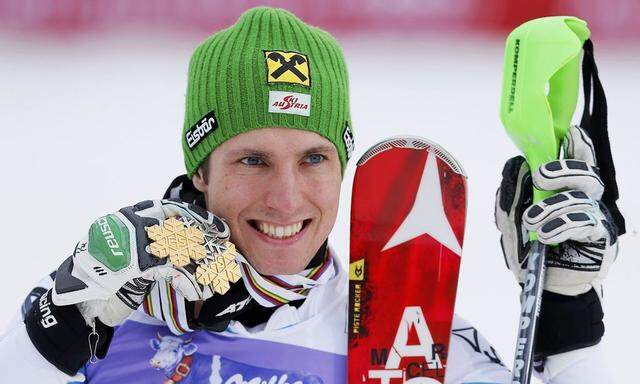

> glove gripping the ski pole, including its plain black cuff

[{"left": 495, "top": 127, "right": 618, "bottom": 356}]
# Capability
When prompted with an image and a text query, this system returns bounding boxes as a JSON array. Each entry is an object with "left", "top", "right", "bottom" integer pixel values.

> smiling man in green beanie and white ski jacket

[{"left": 0, "top": 8, "right": 616, "bottom": 384}]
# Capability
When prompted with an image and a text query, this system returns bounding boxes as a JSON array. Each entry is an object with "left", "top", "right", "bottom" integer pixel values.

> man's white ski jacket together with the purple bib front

[{"left": 0, "top": 254, "right": 611, "bottom": 384}]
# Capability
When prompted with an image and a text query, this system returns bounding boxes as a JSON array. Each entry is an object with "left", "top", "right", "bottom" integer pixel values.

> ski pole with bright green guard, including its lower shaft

[{"left": 500, "top": 16, "right": 589, "bottom": 384}]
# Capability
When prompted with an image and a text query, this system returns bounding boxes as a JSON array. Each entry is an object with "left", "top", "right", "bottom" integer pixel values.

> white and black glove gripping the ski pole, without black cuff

[{"left": 495, "top": 126, "right": 618, "bottom": 296}]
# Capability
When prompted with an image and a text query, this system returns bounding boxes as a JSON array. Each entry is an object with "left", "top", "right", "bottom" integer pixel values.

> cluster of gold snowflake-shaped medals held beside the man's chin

[{"left": 145, "top": 217, "right": 241, "bottom": 295}]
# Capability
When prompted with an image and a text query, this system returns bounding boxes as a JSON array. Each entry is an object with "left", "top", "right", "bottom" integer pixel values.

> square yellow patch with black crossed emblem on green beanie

[{"left": 264, "top": 51, "right": 311, "bottom": 87}]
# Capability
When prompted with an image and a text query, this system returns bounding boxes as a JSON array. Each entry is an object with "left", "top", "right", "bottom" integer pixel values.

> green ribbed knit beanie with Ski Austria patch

[{"left": 182, "top": 7, "right": 354, "bottom": 177}]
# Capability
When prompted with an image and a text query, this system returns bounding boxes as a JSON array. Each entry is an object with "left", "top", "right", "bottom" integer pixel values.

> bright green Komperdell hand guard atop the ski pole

[{"left": 500, "top": 16, "right": 590, "bottom": 238}]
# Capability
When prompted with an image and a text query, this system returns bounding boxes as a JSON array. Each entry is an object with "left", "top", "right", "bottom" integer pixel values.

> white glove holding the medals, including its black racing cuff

[{"left": 24, "top": 200, "right": 236, "bottom": 375}]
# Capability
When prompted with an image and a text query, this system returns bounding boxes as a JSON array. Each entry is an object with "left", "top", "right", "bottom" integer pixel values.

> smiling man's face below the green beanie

[{"left": 193, "top": 128, "right": 342, "bottom": 275}]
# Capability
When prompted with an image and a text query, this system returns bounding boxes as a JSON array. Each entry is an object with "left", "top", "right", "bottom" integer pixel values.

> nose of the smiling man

[{"left": 266, "top": 167, "right": 304, "bottom": 215}]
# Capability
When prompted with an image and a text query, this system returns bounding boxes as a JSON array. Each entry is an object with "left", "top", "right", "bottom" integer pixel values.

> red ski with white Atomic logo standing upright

[{"left": 348, "top": 137, "right": 466, "bottom": 384}]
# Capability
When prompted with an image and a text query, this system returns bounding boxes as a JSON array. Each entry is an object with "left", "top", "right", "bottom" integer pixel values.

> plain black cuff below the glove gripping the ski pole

[{"left": 534, "top": 288, "right": 604, "bottom": 358}]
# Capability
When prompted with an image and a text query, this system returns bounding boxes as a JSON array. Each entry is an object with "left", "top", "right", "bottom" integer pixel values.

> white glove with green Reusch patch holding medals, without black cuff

[{"left": 52, "top": 200, "right": 229, "bottom": 326}]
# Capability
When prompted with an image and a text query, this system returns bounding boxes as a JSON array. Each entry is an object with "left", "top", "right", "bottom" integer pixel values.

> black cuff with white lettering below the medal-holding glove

[{"left": 24, "top": 290, "right": 113, "bottom": 376}]
